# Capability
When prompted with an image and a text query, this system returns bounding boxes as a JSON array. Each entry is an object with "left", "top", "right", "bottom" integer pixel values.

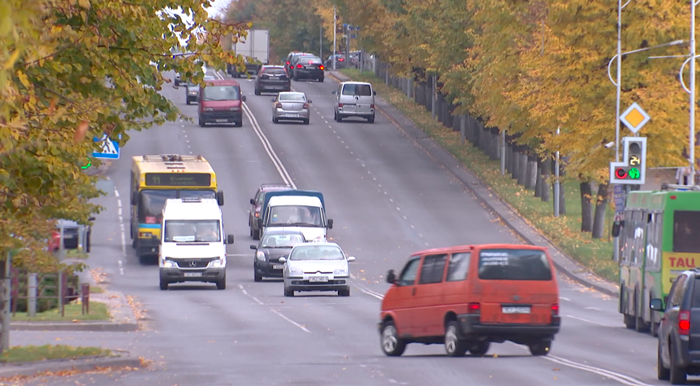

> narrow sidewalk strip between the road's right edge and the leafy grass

[{"left": 327, "top": 71, "right": 619, "bottom": 297}]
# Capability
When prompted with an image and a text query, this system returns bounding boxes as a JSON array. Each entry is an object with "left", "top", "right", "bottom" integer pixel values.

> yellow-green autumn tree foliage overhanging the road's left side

[{"left": 0, "top": 0, "right": 249, "bottom": 270}]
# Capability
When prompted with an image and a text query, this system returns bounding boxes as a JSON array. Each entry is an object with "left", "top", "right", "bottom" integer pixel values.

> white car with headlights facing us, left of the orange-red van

[{"left": 279, "top": 242, "right": 355, "bottom": 296}]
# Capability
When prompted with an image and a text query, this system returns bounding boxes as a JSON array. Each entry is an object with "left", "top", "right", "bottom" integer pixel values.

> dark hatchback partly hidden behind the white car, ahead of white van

[{"left": 250, "top": 230, "right": 306, "bottom": 281}]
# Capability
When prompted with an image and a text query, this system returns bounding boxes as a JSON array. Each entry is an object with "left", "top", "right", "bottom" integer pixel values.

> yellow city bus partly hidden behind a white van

[{"left": 130, "top": 154, "right": 224, "bottom": 263}]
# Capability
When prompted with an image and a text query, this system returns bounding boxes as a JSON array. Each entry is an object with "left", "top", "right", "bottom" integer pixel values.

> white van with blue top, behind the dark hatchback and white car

[{"left": 262, "top": 196, "right": 333, "bottom": 241}]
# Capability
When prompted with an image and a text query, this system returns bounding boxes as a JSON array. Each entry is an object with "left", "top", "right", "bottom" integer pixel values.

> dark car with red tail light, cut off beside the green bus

[{"left": 649, "top": 268, "right": 700, "bottom": 385}]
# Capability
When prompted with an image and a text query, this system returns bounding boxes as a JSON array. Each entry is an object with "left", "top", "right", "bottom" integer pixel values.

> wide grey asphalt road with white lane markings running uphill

[{"left": 13, "top": 70, "right": 684, "bottom": 386}]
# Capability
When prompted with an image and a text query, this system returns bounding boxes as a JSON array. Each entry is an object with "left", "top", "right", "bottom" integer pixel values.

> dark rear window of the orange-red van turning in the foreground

[{"left": 479, "top": 249, "right": 552, "bottom": 280}]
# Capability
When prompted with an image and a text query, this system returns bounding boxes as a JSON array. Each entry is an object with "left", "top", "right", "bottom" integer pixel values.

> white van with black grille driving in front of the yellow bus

[{"left": 158, "top": 198, "right": 233, "bottom": 290}]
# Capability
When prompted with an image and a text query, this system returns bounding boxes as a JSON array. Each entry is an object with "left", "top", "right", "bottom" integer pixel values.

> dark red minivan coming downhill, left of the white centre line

[{"left": 198, "top": 79, "right": 245, "bottom": 127}]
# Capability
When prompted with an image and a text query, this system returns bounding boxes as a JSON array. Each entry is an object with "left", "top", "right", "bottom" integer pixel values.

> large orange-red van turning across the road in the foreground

[{"left": 379, "top": 244, "right": 561, "bottom": 356}]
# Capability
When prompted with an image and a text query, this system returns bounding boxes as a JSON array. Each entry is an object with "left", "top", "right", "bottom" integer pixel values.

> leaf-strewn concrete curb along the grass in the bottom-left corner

[{"left": 0, "top": 357, "right": 145, "bottom": 379}]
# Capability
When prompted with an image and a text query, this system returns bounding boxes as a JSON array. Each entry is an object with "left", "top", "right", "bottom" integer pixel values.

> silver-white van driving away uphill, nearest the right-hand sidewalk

[{"left": 333, "top": 82, "right": 377, "bottom": 123}]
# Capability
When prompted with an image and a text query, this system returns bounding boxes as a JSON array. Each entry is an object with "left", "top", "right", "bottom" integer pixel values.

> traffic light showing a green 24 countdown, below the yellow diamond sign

[{"left": 610, "top": 137, "right": 647, "bottom": 185}]
